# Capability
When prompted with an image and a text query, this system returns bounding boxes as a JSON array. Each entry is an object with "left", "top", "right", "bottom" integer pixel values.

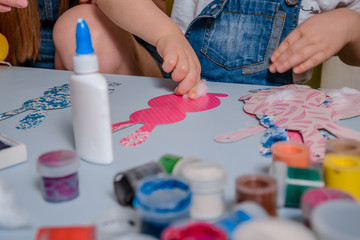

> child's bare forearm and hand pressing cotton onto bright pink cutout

[{"left": 96, "top": 0, "right": 201, "bottom": 98}]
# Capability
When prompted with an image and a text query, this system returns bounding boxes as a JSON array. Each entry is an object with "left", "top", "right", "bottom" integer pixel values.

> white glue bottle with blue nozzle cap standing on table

[{"left": 70, "top": 18, "right": 113, "bottom": 164}]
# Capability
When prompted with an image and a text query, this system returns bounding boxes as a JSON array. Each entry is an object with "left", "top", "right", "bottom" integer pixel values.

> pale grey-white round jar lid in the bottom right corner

[{"left": 311, "top": 200, "right": 360, "bottom": 240}]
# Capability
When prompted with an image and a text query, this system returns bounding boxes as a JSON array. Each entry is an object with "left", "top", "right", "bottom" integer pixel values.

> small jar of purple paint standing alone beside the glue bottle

[{"left": 37, "top": 150, "right": 80, "bottom": 202}]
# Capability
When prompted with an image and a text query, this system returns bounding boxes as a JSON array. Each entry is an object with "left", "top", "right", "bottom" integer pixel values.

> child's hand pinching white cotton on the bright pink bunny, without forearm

[{"left": 156, "top": 32, "right": 201, "bottom": 99}]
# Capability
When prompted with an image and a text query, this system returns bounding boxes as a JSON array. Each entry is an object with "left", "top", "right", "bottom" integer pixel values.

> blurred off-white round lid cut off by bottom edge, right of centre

[{"left": 233, "top": 218, "right": 316, "bottom": 240}]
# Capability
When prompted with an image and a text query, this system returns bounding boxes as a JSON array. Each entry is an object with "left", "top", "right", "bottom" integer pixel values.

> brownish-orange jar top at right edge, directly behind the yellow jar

[{"left": 326, "top": 139, "right": 360, "bottom": 156}]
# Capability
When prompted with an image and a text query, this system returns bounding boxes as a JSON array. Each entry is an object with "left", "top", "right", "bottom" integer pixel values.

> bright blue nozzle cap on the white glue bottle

[{"left": 76, "top": 18, "right": 94, "bottom": 55}]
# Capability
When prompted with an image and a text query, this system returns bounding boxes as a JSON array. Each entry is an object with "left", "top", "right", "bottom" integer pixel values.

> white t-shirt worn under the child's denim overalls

[{"left": 171, "top": 0, "right": 360, "bottom": 83}]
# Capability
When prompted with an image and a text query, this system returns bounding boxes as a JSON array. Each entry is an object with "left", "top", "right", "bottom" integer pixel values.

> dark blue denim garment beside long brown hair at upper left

[{"left": 22, "top": 0, "right": 72, "bottom": 68}]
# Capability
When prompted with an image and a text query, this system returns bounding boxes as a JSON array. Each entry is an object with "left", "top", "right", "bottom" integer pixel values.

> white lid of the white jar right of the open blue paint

[{"left": 182, "top": 161, "right": 226, "bottom": 193}]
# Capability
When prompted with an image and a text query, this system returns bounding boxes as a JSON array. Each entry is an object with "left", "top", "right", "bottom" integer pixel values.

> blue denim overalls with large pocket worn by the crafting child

[{"left": 185, "top": 0, "right": 301, "bottom": 85}]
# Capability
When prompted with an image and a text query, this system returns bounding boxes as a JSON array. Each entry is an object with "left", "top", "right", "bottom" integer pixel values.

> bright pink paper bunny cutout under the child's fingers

[{"left": 112, "top": 93, "right": 228, "bottom": 147}]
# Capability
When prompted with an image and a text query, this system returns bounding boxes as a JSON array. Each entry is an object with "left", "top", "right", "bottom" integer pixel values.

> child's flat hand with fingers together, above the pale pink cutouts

[{"left": 269, "top": 8, "right": 360, "bottom": 73}]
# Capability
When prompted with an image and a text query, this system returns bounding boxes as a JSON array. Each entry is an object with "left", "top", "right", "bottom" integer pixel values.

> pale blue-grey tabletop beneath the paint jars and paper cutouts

[{"left": 0, "top": 67, "right": 360, "bottom": 240}]
